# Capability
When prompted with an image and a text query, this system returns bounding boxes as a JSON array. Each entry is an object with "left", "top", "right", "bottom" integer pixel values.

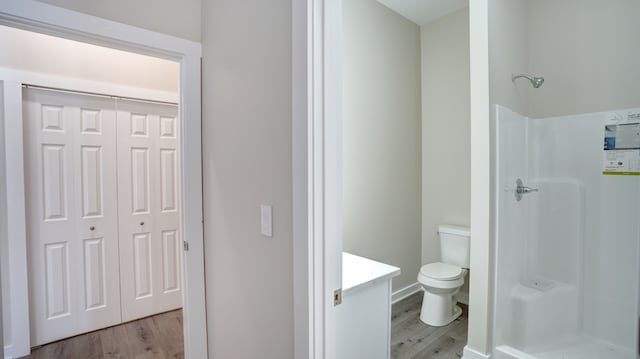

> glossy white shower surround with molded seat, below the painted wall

[{"left": 494, "top": 106, "right": 640, "bottom": 359}]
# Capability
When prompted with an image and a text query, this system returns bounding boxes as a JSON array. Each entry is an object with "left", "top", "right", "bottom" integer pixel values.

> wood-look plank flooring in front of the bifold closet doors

[{"left": 24, "top": 309, "right": 184, "bottom": 359}]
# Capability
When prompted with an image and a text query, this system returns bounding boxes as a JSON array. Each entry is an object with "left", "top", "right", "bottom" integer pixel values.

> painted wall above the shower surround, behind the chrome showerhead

[{"left": 489, "top": 0, "right": 640, "bottom": 118}]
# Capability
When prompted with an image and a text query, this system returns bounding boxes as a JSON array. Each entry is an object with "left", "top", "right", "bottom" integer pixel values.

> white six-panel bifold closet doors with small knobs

[{"left": 23, "top": 88, "right": 182, "bottom": 345}]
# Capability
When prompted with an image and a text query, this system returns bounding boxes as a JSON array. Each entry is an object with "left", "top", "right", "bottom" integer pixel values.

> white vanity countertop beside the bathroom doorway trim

[{"left": 342, "top": 252, "right": 400, "bottom": 296}]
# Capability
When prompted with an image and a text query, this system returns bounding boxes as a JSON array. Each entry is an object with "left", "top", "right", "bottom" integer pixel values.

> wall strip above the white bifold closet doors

[{"left": 0, "top": 26, "right": 180, "bottom": 93}]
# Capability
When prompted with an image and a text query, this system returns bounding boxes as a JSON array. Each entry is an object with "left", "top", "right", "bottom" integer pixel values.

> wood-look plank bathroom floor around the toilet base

[{"left": 391, "top": 292, "right": 468, "bottom": 359}]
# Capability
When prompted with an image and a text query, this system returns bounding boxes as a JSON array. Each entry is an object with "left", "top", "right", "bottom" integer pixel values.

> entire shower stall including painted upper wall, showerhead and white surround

[{"left": 489, "top": 0, "right": 640, "bottom": 359}]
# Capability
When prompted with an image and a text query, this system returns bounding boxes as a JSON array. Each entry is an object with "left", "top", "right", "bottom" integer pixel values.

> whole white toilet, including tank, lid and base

[{"left": 418, "top": 225, "right": 470, "bottom": 327}]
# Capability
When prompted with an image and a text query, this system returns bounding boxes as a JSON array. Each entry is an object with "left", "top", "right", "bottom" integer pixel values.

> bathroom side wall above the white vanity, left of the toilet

[{"left": 343, "top": 0, "right": 421, "bottom": 290}]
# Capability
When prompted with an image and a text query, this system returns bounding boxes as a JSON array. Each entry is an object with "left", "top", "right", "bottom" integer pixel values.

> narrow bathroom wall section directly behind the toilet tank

[{"left": 421, "top": 9, "right": 471, "bottom": 270}]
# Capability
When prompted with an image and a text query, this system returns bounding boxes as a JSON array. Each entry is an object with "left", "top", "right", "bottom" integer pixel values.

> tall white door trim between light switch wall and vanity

[{"left": 292, "top": 0, "right": 342, "bottom": 359}]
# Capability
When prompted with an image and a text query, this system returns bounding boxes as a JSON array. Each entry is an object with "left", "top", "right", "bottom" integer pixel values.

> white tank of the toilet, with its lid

[{"left": 438, "top": 224, "right": 470, "bottom": 268}]
